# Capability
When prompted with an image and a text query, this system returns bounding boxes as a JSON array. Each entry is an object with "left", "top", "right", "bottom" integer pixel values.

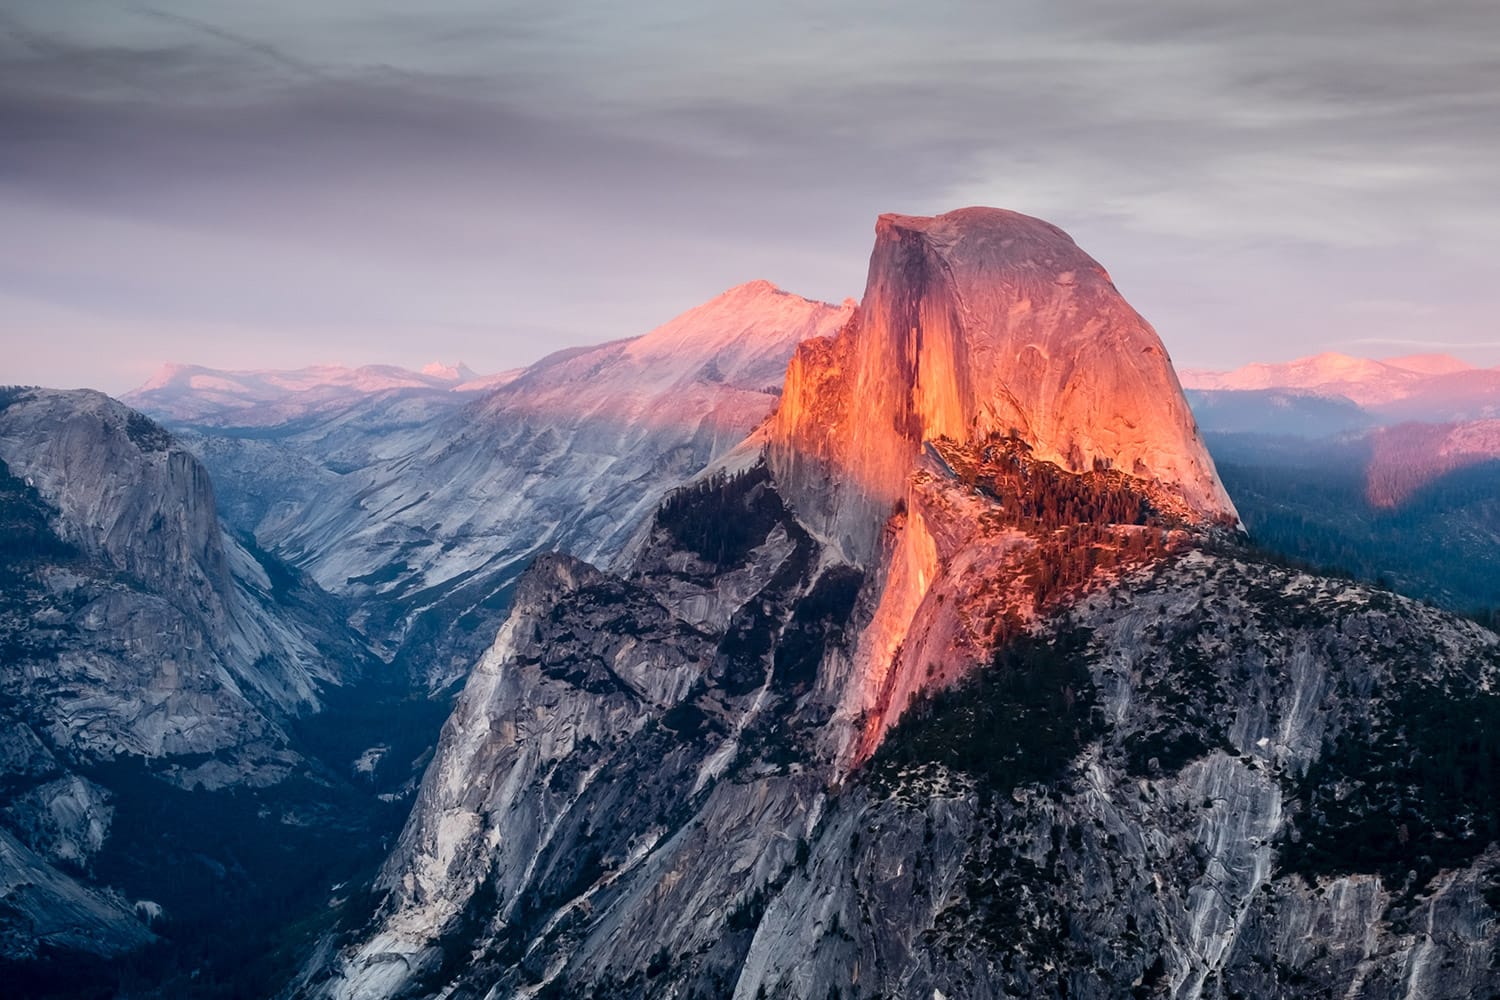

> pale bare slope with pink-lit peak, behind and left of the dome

[{"left": 265, "top": 282, "right": 849, "bottom": 685}]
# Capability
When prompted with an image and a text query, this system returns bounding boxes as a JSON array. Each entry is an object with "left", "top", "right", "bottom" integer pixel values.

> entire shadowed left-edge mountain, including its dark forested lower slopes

[{"left": 0, "top": 388, "right": 381, "bottom": 996}]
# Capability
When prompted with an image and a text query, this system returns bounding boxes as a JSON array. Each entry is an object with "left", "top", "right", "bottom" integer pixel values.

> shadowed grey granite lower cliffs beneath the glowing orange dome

[{"left": 299, "top": 491, "right": 1500, "bottom": 1000}]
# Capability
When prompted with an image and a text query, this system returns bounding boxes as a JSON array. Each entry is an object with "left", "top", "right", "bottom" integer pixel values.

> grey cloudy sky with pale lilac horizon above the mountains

[{"left": 0, "top": 0, "right": 1500, "bottom": 393}]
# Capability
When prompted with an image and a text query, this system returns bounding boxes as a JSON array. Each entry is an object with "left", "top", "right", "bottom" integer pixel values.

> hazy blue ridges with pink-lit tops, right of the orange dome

[{"left": 1184, "top": 354, "right": 1500, "bottom": 616}]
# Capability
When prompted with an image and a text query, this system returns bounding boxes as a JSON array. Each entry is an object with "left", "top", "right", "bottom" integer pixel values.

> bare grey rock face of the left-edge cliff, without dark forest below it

[{"left": 0, "top": 390, "right": 348, "bottom": 756}]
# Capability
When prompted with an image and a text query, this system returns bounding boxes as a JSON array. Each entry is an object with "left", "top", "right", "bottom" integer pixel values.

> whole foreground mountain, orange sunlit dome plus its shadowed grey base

[{"left": 291, "top": 210, "right": 1500, "bottom": 1000}]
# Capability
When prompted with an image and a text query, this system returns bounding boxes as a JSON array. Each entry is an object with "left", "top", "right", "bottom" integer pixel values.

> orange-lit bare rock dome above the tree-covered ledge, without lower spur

[{"left": 771, "top": 208, "right": 1236, "bottom": 561}]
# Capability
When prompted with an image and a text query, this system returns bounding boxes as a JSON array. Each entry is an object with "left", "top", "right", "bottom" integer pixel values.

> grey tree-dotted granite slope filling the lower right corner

[{"left": 735, "top": 553, "right": 1500, "bottom": 999}]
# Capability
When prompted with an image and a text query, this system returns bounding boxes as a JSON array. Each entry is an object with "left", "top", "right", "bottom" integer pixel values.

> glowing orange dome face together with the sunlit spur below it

[{"left": 767, "top": 208, "right": 1238, "bottom": 760}]
